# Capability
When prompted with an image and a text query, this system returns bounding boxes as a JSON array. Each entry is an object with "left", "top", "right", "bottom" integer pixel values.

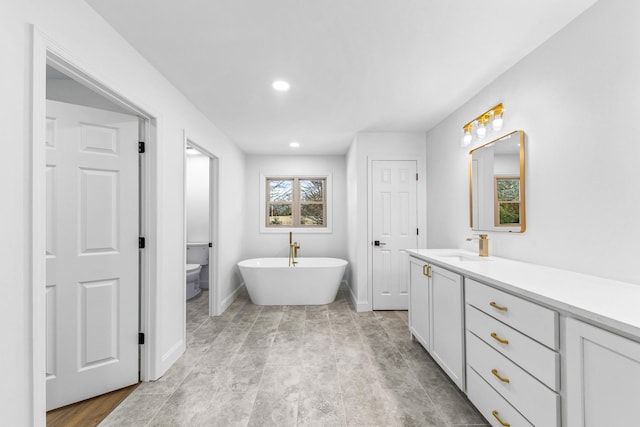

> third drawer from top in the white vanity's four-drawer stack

[{"left": 467, "top": 332, "right": 560, "bottom": 427}]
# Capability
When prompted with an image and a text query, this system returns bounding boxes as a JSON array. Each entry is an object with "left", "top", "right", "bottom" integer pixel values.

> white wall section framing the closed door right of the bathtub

[{"left": 346, "top": 132, "right": 427, "bottom": 311}]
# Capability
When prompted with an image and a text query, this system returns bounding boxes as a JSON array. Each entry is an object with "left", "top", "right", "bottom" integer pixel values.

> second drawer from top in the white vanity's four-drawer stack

[{"left": 465, "top": 304, "right": 560, "bottom": 391}]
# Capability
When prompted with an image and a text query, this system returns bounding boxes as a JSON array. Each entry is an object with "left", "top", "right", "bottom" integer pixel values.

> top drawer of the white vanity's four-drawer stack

[{"left": 465, "top": 279, "right": 559, "bottom": 350}]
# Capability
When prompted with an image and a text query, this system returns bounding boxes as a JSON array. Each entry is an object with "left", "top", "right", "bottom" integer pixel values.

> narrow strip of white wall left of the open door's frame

[{"left": 0, "top": 1, "right": 30, "bottom": 425}]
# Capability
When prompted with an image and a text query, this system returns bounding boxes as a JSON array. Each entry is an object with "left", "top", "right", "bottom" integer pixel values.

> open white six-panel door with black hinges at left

[{"left": 46, "top": 101, "right": 138, "bottom": 410}]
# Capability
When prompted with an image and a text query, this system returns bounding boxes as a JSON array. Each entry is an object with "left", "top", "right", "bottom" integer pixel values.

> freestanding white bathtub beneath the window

[{"left": 238, "top": 258, "right": 348, "bottom": 305}]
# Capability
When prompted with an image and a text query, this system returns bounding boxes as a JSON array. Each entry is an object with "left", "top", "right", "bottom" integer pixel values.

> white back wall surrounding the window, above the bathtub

[{"left": 243, "top": 156, "right": 347, "bottom": 259}]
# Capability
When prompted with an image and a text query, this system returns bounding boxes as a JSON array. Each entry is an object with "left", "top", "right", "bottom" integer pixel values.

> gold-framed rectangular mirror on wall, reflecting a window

[{"left": 469, "top": 130, "right": 526, "bottom": 233}]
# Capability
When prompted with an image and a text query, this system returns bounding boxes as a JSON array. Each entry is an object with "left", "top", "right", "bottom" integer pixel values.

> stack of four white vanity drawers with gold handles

[{"left": 465, "top": 278, "right": 561, "bottom": 427}]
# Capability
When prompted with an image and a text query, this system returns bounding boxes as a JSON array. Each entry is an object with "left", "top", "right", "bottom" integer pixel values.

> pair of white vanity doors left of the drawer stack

[{"left": 409, "top": 257, "right": 465, "bottom": 390}]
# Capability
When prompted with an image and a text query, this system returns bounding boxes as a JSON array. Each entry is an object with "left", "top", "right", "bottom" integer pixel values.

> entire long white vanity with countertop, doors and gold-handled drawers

[{"left": 408, "top": 249, "right": 640, "bottom": 427}]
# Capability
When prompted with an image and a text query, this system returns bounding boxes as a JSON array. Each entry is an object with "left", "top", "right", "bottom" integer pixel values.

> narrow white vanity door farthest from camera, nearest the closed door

[{"left": 409, "top": 257, "right": 430, "bottom": 350}]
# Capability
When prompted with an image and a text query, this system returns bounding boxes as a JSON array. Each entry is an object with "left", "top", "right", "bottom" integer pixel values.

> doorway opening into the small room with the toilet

[{"left": 184, "top": 135, "right": 219, "bottom": 316}]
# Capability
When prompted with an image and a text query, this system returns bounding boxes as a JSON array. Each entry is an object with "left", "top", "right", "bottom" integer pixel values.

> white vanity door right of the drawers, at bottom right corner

[{"left": 566, "top": 319, "right": 640, "bottom": 427}]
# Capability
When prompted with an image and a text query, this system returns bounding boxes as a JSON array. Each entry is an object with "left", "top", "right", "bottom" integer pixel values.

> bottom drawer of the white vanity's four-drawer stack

[{"left": 467, "top": 365, "right": 533, "bottom": 427}]
